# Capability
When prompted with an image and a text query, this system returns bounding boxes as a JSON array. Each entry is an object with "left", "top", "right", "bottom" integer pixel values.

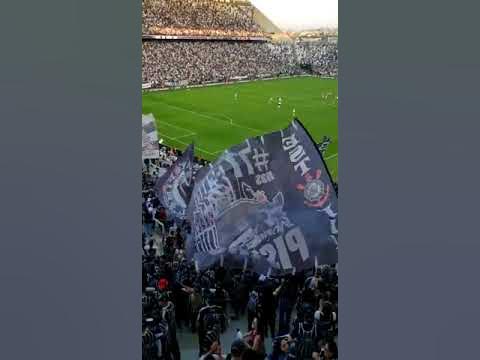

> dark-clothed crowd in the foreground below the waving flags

[{"left": 142, "top": 149, "right": 338, "bottom": 360}]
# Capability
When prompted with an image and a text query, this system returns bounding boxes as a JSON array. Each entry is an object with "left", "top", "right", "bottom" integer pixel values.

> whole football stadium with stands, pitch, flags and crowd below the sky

[{"left": 142, "top": 0, "right": 338, "bottom": 360}]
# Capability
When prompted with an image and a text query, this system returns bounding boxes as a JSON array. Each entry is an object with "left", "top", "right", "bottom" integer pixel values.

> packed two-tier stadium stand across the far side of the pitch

[{"left": 142, "top": 0, "right": 338, "bottom": 88}]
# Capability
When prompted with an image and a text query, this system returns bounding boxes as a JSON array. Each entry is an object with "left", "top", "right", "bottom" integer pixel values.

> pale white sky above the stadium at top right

[{"left": 250, "top": 0, "right": 338, "bottom": 30}]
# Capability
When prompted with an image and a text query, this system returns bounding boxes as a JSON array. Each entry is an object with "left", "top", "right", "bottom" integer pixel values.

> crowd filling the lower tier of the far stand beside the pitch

[{"left": 142, "top": 40, "right": 338, "bottom": 87}]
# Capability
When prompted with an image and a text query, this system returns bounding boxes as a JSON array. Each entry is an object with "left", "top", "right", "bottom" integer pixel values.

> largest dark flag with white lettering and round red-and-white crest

[{"left": 187, "top": 120, "right": 338, "bottom": 271}]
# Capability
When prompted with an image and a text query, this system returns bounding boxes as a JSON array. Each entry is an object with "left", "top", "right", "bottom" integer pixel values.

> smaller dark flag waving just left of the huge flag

[{"left": 155, "top": 144, "right": 193, "bottom": 221}]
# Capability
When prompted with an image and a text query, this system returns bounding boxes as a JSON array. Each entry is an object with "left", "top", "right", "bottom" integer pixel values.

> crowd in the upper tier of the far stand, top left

[{"left": 142, "top": 0, "right": 260, "bottom": 34}]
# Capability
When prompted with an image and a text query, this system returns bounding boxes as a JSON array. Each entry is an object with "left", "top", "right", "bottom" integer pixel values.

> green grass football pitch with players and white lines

[{"left": 142, "top": 77, "right": 338, "bottom": 179}]
